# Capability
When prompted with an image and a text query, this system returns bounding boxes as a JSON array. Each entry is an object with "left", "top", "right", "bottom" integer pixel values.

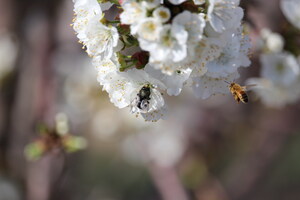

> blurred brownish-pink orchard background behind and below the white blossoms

[{"left": 0, "top": 0, "right": 300, "bottom": 200}]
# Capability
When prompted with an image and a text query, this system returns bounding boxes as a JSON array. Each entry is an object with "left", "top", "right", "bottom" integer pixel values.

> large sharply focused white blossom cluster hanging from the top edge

[{"left": 73, "top": 0, "right": 250, "bottom": 121}]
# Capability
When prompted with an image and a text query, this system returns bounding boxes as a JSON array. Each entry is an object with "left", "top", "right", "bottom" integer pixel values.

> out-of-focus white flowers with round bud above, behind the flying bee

[{"left": 247, "top": 29, "right": 300, "bottom": 108}]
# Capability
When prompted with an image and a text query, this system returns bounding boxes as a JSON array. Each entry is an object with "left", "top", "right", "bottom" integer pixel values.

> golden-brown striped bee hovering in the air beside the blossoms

[{"left": 225, "top": 81, "right": 255, "bottom": 103}]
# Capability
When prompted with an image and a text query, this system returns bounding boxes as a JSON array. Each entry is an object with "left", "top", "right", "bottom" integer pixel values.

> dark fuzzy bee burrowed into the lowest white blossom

[{"left": 131, "top": 85, "right": 151, "bottom": 113}]
